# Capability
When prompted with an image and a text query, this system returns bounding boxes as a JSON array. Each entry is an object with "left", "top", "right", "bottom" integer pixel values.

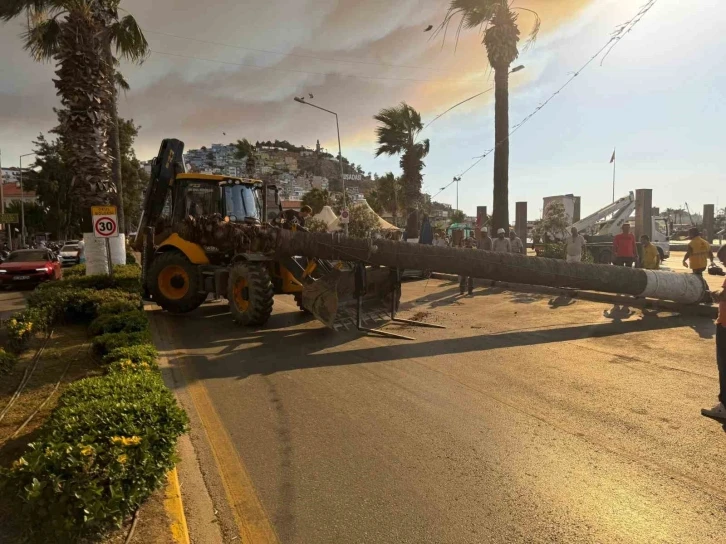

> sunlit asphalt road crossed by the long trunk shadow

[{"left": 152, "top": 280, "right": 726, "bottom": 544}]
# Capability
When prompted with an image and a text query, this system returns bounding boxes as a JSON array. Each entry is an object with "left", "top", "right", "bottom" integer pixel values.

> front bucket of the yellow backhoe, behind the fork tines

[{"left": 302, "top": 265, "right": 401, "bottom": 330}]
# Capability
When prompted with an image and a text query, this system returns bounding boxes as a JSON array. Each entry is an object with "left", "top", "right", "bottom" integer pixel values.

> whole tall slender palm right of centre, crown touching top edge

[{"left": 439, "top": 0, "right": 540, "bottom": 229}]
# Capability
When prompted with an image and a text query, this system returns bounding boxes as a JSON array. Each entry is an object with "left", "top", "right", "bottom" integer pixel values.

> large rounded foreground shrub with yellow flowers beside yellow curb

[{"left": 1, "top": 372, "right": 187, "bottom": 542}]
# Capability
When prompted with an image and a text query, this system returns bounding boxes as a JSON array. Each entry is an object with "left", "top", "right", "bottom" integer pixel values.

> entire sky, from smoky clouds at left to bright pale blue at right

[{"left": 0, "top": 0, "right": 726, "bottom": 218}]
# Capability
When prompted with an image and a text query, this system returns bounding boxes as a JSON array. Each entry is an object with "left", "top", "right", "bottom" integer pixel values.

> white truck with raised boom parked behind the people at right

[{"left": 535, "top": 191, "right": 671, "bottom": 264}]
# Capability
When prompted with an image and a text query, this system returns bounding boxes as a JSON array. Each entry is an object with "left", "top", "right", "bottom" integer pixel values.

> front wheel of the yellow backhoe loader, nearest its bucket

[{"left": 227, "top": 263, "right": 275, "bottom": 326}]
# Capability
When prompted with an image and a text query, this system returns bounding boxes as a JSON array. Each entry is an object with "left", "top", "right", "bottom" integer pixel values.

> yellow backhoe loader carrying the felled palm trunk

[{"left": 134, "top": 139, "right": 400, "bottom": 328}]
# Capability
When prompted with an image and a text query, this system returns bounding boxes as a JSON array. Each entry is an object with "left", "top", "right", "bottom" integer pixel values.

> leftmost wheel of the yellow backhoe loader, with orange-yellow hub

[{"left": 147, "top": 251, "right": 207, "bottom": 314}]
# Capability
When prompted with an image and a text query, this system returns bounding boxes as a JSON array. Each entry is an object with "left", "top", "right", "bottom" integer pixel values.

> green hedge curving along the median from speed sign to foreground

[{"left": 0, "top": 258, "right": 188, "bottom": 542}]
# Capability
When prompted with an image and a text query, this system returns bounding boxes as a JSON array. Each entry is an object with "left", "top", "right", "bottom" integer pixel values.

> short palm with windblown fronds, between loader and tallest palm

[{"left": 373, "top": 102, "right": 429, "bottom": 238}]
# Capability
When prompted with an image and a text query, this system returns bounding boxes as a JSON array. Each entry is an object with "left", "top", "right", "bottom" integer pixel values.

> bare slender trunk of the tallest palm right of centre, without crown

[{"left": 492, "top": 66, "right": 509, "bottom": 232}]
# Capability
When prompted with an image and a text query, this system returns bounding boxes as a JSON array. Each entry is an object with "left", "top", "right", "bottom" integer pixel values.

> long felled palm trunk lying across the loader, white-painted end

[{"left": 176, "top": 216, "right": 709, "bottom": 304}]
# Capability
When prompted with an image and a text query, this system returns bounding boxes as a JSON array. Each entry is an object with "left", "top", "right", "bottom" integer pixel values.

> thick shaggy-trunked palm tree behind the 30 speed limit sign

[{"left": 0, "top": 0, "right": 148, "bottom": 224}]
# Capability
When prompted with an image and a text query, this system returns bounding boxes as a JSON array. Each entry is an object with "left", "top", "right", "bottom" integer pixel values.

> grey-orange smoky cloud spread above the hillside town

[{"left": 0, "top": 0, "right": 591, "bottom": 166}]
